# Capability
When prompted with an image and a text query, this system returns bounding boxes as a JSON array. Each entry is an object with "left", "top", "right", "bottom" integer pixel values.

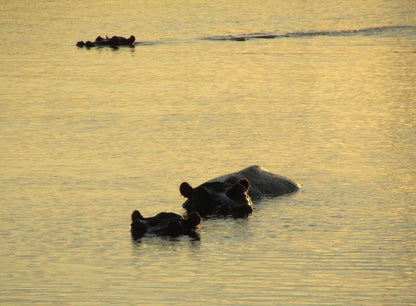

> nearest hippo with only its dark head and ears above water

[{"left": 130, "top": 210, "right": 201, "bottom": 240}]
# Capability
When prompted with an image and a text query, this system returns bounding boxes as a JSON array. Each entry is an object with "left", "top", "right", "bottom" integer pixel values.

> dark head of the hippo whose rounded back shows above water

[{"left": 179, "top": 178, "right": 253, "bottom": 218}]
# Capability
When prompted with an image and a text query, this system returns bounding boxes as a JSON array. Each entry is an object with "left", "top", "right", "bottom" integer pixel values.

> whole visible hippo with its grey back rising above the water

[{"left": 179, "top": 166, "right": 300, "bottom": 218}]
